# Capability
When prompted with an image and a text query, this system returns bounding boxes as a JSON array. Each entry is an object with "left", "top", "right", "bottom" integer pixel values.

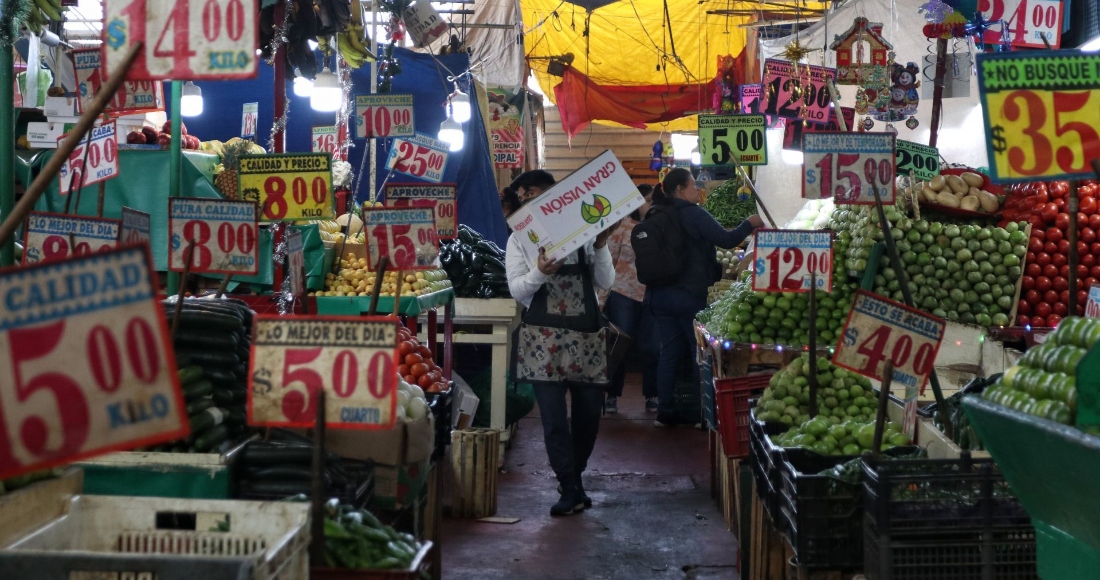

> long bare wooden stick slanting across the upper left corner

[{"left": 0, "top": 42, "right": 143, "bottom": 245}]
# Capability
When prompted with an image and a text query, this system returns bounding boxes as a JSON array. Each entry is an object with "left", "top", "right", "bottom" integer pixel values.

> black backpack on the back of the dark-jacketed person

[{"left": 630, "top": 206, "right": 688, "bottom": 287}]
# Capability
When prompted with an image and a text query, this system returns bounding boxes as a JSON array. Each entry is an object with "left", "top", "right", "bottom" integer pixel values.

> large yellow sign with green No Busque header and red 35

[{"left": 978, "top": 51, "right": 1100, "bottom": 183}]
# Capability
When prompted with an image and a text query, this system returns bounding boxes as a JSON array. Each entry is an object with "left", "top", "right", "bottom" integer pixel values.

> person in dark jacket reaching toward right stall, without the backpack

[{"left": 645, "top": 167, "right": 763, "bottom": 427}]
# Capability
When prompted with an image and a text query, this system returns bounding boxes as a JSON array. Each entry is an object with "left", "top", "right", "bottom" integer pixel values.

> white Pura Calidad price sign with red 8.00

[{"left": 168, "top": 197, "right": 260, "bottom": 274}]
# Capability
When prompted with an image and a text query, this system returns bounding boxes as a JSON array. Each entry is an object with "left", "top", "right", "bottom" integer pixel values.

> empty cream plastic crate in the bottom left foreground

[{"left": 0, "top": 495, "right": 309, "bottom": 580}]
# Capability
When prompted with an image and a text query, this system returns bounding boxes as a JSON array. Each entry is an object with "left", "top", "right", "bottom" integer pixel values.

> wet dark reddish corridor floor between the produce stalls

[{"left": 442, "top": 374, "right": 738, "bottom": 580}]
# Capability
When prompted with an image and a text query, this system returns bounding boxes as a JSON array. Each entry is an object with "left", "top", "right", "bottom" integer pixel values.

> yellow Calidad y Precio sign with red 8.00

[{"left": 239, "top": 153, "right": 333, "bottom": 221}]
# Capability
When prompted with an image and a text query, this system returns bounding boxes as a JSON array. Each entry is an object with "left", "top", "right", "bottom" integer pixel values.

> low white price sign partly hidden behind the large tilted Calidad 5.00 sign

[{"left": 23, "top": 211, "right": 121, "bottom": 265}]
